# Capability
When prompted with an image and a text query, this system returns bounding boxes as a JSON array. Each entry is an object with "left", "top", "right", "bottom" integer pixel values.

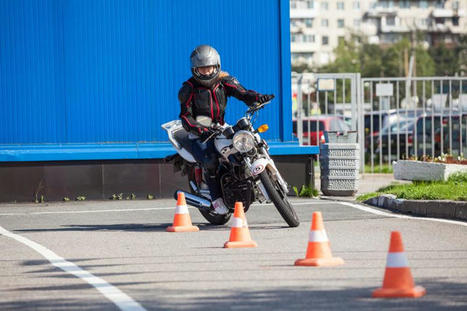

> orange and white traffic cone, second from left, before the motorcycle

[{"left": 224, "top": 202, "right": 258, "bottom": 248}]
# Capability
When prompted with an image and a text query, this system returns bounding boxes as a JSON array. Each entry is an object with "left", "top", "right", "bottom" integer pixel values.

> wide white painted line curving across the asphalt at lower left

[{"left": 0, "top": 227, "right": 146, "bottom": 311}]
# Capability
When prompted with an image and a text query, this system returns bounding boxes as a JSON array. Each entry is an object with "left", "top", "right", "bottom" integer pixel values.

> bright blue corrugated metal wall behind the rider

[{"left": 0, "top": 0, "right": 292, "bottom": 161}]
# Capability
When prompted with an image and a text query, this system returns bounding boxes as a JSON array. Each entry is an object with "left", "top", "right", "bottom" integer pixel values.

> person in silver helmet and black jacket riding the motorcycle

[{"left": 178, "top": 45, "right": 274, "bottom": 215}]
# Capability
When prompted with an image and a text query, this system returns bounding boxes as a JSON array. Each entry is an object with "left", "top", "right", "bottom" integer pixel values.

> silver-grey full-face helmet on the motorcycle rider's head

[{"left": 190, "top": 45, "right": 221, "bottom": 87}]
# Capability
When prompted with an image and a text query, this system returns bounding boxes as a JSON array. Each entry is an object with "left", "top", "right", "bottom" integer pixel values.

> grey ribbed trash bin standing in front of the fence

[{"left": 319, "top": 131, "right": 360, "bottom": 196}]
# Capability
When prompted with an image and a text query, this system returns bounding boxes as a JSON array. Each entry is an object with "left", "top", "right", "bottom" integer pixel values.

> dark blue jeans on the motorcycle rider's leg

[{"left": 192, "top": 139, "right": 222, "bottom": 201}]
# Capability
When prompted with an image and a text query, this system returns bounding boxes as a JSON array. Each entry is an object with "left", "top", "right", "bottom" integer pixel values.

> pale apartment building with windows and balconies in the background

[{"left": 290, "top": 0, "right": 467, "bottom": 68}]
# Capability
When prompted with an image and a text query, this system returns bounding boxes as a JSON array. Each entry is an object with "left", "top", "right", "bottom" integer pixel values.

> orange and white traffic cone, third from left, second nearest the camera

[{"left": 295, "top": 212, "right": 344, "bottom": 266}]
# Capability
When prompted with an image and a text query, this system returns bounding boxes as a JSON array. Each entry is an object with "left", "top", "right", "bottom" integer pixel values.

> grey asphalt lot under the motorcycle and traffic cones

[{"left": 0, "top": 199, "right": 467, "bottom": 310}]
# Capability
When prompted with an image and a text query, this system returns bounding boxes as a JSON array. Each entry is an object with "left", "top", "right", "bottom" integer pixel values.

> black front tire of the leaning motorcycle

[{"left": 259, "top": 169, "right": 300, "bottom": 227}]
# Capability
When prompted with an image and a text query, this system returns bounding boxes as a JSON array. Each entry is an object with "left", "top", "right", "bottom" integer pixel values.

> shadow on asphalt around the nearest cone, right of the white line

[{"left": 139, "top": 279, "right": 467, "bottom": 311}]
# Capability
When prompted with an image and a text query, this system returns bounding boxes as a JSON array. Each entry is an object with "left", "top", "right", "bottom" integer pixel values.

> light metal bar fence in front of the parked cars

[{"left": 292, "top": 73, "right": 467, "bottom": 172}]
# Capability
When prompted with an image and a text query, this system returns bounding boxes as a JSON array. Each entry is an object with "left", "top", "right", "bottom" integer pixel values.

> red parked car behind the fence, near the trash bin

[{"left": 293, "top": 115, "right": 350, "bottom": 146}]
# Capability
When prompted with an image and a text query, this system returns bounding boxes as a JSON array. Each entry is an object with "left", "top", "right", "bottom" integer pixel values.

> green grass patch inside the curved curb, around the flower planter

[{"left": 357, "top": 173, "right": 467, "bottom": 201}]
